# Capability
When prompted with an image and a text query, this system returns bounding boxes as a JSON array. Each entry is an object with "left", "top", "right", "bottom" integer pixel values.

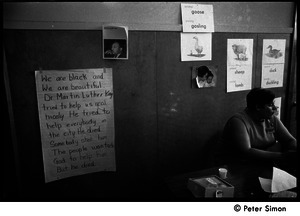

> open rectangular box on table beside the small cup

[{"left": 188, "top": 175, "right": 234, "bottom": 198}]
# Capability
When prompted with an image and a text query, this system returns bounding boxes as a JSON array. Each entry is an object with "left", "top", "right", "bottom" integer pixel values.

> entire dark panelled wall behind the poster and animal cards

[{"left": 4, "top": 30, "right": 290, "bottom": 201}]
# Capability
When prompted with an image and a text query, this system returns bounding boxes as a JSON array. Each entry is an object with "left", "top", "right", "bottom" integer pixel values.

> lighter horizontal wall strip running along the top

[{"left": 3, "top": 2, "right": 295, "bottom": 33}]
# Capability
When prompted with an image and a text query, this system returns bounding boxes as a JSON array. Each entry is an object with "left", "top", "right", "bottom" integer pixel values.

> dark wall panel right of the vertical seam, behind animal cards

[{"left": 157, "top": 32, "right": 290, "bottom": 172}]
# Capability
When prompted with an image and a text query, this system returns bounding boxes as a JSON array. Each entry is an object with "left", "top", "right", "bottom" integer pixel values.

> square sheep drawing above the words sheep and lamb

[{"left": 227, "top": 39, "right": 253, "bottom": 65}]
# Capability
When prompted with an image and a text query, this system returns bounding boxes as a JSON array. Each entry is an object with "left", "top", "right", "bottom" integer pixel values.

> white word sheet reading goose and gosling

[{"left": 181, "top": 4, "right": 215, "bottom": 32}]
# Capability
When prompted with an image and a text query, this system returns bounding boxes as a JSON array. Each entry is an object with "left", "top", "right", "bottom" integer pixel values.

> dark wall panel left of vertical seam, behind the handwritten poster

[{"left": 4, "top": 30, "right": 157, "bottom": 200}]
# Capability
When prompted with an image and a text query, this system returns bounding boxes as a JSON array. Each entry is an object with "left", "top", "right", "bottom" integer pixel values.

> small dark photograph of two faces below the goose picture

[{"left": 192, "top": 65, "right": 218, "bottom": 89}]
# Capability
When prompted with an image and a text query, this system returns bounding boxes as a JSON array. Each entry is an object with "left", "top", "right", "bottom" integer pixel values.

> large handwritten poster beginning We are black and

[{"left": 35, "top": 68, "right": 116, "bottom": 182}]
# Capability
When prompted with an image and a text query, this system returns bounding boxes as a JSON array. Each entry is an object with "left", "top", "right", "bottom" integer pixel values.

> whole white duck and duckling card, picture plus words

[{"left": 261, "top": 39, "right": 286, "bottom": 88}]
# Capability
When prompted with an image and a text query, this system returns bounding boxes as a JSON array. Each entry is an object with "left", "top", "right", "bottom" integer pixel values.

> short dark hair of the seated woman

[{"left": 247, "top": 88, "right": 275, "bottom": 109}]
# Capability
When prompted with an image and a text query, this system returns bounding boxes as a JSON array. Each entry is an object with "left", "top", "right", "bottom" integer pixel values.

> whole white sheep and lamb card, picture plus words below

[{"left": 227, "top": 39, "right": 253, "bottom": 92}]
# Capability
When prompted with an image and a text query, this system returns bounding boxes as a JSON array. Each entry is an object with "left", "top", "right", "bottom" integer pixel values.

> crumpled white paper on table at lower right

[{"left": 258, "top": 167, "right": 297, "bottom": 193}]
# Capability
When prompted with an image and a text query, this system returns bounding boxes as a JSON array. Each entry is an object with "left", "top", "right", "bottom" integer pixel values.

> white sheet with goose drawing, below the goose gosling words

[{"left": 180, "top": 33, "right": 212, "bottom": 61}]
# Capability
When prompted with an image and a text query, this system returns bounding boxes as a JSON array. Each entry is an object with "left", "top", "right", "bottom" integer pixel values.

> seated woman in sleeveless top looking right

[{"left": 223, "top": 88, "right": 297, "bottom": 171}]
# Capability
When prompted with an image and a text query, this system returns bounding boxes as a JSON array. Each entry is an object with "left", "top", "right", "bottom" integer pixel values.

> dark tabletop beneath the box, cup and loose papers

[{"left": 165, "top": 164, "right": 290, "bottom": 201}]
